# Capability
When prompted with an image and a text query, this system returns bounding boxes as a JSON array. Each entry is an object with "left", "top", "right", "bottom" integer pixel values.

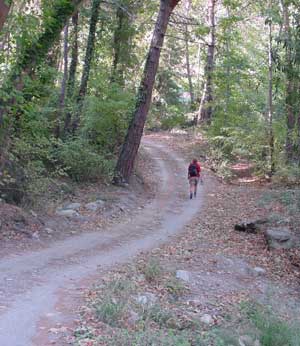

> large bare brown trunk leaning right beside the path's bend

[{"left": 114, "top": 0, "right": 180, "bottom": 183}]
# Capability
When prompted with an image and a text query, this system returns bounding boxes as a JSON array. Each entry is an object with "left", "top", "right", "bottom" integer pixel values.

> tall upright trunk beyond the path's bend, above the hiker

[{"left": 195, "top": 0, "right": 217, "bottom": 125}]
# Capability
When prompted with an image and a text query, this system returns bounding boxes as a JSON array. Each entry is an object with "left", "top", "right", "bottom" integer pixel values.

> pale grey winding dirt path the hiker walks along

[{"left": 0, "top": 137, "right": 208, "bottom": 346}]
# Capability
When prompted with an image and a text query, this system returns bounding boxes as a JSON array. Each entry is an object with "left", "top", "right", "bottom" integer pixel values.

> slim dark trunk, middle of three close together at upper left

[{"left": 63, "top": 11, "right": 79, "bottom": 136}]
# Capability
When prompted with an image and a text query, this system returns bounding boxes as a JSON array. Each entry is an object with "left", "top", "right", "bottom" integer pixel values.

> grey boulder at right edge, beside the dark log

[{"left": 265, "top": 228, "right": 296, "bottom": 249}]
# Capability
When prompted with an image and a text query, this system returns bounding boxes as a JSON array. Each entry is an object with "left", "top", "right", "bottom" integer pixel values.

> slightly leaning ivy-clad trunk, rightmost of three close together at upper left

[{"left": 72, "top": 0, "right": 101, "bottom": 133}]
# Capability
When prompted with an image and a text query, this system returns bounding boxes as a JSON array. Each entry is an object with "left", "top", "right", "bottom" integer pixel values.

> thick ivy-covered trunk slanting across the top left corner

[{"left": 0, "top": 0, "right": 82, "bottom": 127}]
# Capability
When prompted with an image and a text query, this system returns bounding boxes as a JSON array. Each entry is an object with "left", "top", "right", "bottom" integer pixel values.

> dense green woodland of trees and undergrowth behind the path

[{"left": 0, "top": 0, "right": 300, "bottom": 203}]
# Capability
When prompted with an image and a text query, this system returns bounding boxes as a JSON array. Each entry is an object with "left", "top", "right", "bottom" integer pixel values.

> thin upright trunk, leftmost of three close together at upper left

[{"left": 54, "top": 24, "right": 69, "bottom": 138}]
